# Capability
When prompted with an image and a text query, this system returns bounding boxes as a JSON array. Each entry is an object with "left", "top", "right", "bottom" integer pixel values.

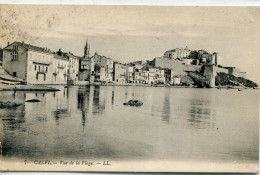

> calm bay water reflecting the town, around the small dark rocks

[{"left": 0, "top": 86, "right": 259, "bottom": 162}]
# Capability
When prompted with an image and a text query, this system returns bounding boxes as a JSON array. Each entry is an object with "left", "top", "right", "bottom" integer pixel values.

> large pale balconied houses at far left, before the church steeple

[{"left": 2, "top": 42, "right": 80, "bottom": 84}]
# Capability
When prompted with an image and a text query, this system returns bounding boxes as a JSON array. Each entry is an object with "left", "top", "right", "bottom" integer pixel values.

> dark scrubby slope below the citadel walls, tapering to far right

[{"left": 215, "top": 72, "right": 258, "bottom": 88}]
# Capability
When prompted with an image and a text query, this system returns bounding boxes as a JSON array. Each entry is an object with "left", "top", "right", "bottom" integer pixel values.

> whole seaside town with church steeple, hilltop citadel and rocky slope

[{"left": 0, "top": 40, "right": 258, "bottom": 88}]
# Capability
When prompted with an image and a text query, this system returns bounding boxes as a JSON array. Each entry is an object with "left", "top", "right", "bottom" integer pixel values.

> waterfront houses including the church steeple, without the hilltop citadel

[{"left": 0, "top": 42, "right": 178, "bottom": 84}]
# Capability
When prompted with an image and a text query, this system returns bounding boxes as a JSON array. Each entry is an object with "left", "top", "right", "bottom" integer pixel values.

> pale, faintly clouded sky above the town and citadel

[{"left": 0, "top": 5, "right": 260, "bottom": 84}]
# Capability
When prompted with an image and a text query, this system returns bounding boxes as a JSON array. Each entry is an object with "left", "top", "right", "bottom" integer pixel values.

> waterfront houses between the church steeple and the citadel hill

[{"left": 80, "top": 52, "right": 179, "bottom": 84}]
